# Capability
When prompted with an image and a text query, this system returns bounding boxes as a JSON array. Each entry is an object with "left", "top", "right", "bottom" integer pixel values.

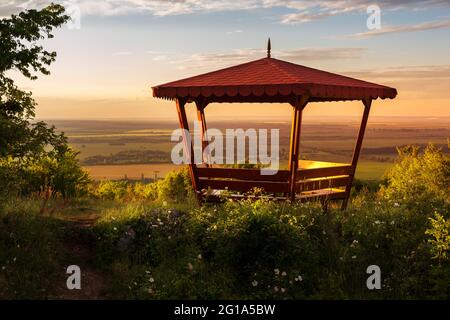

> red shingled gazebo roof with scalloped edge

[{"left": 152, "top": 56, "right": 397, "bottom": 102}]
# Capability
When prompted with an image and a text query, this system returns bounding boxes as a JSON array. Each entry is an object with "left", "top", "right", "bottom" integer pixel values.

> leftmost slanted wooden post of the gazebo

[{"left": 175, "top": 99, "right": 201, "bottom": 203}]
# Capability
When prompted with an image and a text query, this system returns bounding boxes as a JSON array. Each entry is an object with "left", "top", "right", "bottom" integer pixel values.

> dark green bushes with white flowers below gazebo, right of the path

[{"left": 91, "top": 192, "right": 450, "bottom": 299}]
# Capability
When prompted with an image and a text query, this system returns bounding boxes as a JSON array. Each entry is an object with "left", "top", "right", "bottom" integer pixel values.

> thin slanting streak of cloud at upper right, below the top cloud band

[{"left": 341, "top": 19, "right": 450, "bottom": 38}]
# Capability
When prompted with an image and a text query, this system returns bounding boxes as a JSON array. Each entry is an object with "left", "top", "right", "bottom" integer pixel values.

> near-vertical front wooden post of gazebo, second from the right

[{"left": 289, "top": 94, "right": 309, "bottom": 201}]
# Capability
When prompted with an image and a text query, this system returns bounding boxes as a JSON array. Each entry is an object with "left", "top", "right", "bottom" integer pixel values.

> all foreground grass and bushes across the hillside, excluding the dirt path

[{"left": 0, "top": 146, "right": 450, "bottom": 299}]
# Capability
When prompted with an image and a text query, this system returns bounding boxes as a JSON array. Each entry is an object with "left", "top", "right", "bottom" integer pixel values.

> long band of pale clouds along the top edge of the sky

[{"left": 0, "top": 0, "right": 450, "bottom": 19}]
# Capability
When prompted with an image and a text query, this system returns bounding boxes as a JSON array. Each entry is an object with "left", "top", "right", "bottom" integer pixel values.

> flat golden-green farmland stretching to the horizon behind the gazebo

[{"left": 49, "top": 118, "right": 450, "bottom": 180}]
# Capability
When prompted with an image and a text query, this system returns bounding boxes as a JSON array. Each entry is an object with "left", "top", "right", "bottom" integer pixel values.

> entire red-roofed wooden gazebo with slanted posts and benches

[{"left": 152, "top": 39, "right": 397, "bottom": 209}]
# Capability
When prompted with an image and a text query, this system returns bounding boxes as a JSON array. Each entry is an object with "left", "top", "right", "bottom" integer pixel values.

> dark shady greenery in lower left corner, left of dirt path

[{"left": 0, "top": 199, "right": 64, "bottom": 299}]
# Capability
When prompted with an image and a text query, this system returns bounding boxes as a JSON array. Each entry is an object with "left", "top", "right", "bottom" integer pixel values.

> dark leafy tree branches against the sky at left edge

[{"left": 0, "top": 4, "right": 69, "bottom": 158}]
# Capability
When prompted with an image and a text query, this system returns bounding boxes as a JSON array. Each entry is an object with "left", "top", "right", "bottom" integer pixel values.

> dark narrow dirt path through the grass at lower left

[{"left": 52, "top": 213, "right": 108, "bottom": 300}]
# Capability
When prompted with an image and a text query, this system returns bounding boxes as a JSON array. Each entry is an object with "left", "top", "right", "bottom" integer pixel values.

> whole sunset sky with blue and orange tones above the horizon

[{"left": 0, "top": 0, "right": 450, "bottom": 120}]
